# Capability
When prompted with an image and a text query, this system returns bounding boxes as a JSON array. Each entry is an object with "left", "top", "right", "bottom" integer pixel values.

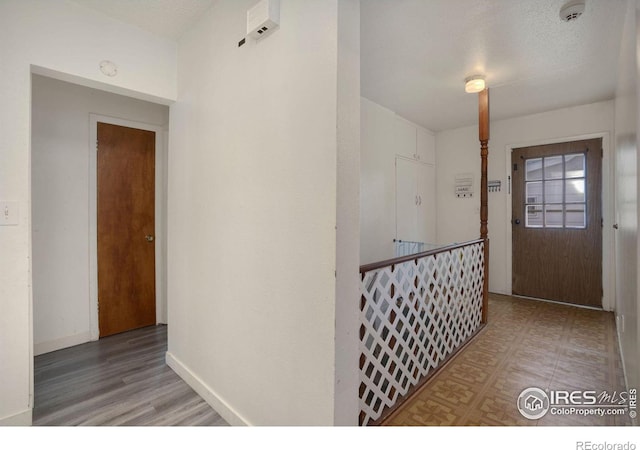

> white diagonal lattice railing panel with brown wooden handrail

[{"left": 359, "top": 240, "right": 485, "bottom": 425}]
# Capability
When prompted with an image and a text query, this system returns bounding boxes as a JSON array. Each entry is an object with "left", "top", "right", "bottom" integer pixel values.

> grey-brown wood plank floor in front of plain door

[{"left": 33, "top": 325, "right": 228, "bottom": 426}]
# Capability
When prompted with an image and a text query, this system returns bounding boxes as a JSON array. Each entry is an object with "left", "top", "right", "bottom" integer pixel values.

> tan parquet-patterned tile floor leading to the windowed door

[{"left": 385, "top": 294, "right": 631, "bottom": 426}]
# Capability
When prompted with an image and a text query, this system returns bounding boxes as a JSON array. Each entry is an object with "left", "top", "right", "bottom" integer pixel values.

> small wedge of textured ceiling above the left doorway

[{"left": 71, "top": 0, "right": 215, "bottom": 40}]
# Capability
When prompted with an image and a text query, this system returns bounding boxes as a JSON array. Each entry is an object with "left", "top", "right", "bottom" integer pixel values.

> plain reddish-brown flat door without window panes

[{"left": 97, "top": 122, "right": 156, "bottom": 337}]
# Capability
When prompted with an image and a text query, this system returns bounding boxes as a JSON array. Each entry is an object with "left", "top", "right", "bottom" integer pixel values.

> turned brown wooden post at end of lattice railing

[{"left": 478, "top": 89, "right": 489, "bottom": 323}]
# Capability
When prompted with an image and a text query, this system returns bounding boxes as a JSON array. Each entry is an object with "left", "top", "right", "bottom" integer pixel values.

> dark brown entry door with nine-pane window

[{"left": 511, "top": 139, "right": 602, "bottom": 307}]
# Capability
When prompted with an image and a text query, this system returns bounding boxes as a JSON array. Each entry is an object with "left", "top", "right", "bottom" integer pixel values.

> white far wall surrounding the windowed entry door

[{"left": 436, "top": 101, "right": 613, "bottom": 294}]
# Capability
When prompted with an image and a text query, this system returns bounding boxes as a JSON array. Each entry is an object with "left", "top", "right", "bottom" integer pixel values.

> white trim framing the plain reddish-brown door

[{"left": 89, "top": 114, "right": 167, "bottom": 341}]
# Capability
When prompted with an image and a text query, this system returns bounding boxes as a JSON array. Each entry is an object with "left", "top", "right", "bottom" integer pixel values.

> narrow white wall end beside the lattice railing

[{"left": 333, "top": 0, "right": 360, "bottom": 425}]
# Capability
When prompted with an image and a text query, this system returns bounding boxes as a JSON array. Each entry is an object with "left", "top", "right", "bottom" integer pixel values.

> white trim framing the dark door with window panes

[{"left": 505, "top": 131, "right": 616, "bottom": 311}]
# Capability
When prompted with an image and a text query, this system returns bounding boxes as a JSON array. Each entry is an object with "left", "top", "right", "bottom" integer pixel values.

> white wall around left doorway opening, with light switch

[{"left": 0, "top": 0, "right": 177, "bottom": 424}]
